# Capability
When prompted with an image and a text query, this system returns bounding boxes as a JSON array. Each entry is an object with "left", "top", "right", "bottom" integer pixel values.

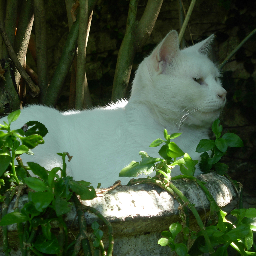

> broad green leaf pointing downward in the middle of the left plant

[{"left": 29, "top": 191, "right": 54, "bottom": 212}]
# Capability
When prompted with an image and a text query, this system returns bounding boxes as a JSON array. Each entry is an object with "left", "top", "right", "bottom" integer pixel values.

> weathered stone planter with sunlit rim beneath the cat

[{"left": 0, "top": 173, "right": 236, "bottom": 256}]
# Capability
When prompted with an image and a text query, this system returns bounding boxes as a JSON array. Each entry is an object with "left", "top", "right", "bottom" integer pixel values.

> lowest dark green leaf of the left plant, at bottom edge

[{"left": 34, "top": 235, "right": 60, "bottom": 254}]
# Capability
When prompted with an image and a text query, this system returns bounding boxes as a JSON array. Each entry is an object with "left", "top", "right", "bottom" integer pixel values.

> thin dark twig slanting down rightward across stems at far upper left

[{"left": 0, "top": 20, "right": 40, "bottom": 97}]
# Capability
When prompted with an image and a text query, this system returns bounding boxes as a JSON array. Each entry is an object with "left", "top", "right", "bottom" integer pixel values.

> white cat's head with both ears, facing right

[{"left": 131, "top": 31, "right": 226, "bottom": 129}]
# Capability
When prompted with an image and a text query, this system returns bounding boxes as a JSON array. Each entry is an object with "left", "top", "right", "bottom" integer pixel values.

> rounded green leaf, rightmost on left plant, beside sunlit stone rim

[{"left": 69, "top": 180, "right": 96, "bottom": 200}]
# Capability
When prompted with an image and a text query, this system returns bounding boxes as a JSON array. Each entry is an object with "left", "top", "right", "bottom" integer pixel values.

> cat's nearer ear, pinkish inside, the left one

[{"left": 150, "top": 30, "right": 180, "bottom": 73}]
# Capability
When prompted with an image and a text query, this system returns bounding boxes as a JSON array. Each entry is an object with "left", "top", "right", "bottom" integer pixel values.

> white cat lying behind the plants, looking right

[{"left": 0, "top": 31, "right": 226, "bottom": 187}]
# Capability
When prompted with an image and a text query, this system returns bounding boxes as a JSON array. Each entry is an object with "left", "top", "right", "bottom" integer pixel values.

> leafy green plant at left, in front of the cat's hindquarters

[{"left": 0, "top": 110, "right": 114, "bottom": 255}]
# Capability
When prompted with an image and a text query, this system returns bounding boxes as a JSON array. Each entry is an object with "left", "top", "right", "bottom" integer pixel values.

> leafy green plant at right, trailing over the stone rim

[{"left": 119, "top": 119, "right": 256, "bottom": 256}]
